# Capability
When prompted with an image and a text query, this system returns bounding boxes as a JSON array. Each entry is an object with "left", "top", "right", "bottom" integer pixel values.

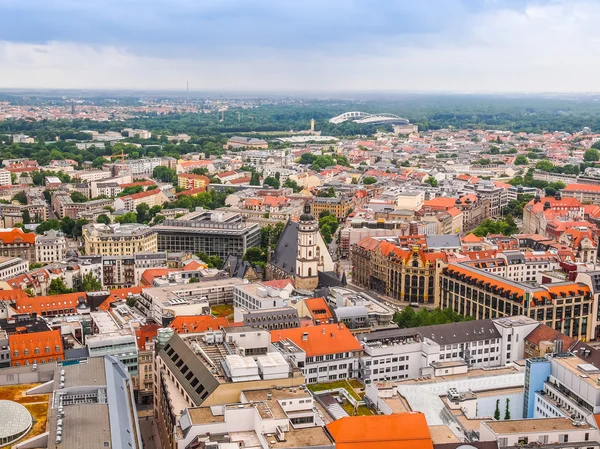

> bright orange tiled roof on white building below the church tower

[{"left": 271, "top": 324, "right": 362, "bottom": 357}]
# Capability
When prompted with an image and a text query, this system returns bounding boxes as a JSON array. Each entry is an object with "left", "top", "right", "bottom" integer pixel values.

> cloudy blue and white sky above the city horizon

[{"left": 0, "top": 0, "right": 600, "bottom": 93}]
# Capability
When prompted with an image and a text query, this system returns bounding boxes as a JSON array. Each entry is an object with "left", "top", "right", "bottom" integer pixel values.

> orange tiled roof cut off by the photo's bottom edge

[{"left": 326, "top": 412, "right": 433, "bottom": 449}]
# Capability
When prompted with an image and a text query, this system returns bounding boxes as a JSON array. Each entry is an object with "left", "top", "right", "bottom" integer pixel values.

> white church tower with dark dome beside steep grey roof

[{"left": 294, "top": 203, "right": 321, "bottom": 290}]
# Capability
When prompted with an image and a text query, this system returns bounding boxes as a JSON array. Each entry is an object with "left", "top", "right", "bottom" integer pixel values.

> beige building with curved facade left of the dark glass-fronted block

[{"left": 83, "top": 223, "right": 158, "bottom": 256}]
